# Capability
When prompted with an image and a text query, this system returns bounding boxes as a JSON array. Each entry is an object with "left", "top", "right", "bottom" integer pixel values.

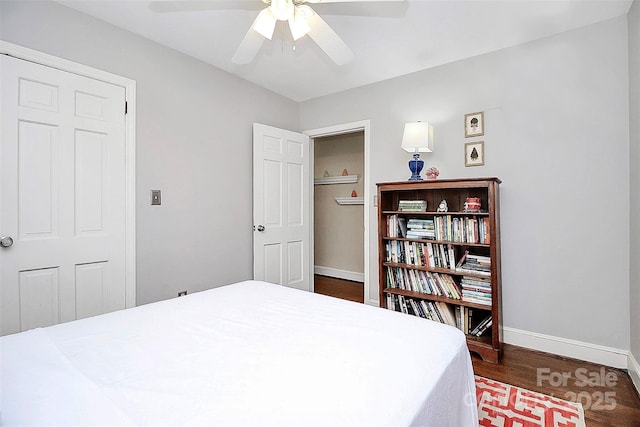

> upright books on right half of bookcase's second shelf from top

[{"left": 434, "top": 215, "right": 491, "bottom": 245}]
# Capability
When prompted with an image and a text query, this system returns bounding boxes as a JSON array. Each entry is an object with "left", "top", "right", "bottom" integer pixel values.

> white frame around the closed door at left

[{"left": 0, "top": 40, "right": 136, "bottom": 308}]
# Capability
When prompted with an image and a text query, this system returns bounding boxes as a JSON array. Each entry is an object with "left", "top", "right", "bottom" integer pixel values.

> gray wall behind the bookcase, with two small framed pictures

[{"left": 300, "top": 17, "right": 629, "bottom": 349}]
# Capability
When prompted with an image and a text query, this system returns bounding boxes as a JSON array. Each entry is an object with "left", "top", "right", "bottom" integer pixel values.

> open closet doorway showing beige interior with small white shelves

[{"left": 304, "top": 120, "right": 370, "bottom": 303}]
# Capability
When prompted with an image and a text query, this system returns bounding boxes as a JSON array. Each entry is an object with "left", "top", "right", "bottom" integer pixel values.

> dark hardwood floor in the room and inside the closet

[{"left": 314, "top": 276, "right": 640, "bottom": 427}]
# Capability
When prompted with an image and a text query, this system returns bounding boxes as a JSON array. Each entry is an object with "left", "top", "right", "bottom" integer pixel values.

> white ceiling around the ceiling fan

[{"left": 58, "top": 0, "right": 632, "bottom": 101}]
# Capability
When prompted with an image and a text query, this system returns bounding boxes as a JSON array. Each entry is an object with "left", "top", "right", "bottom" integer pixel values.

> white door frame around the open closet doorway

[{"left": 302, "top": 120, "right": 378, "bottom": 306}]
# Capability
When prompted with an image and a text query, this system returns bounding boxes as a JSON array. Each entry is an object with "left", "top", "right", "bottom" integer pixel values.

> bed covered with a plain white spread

[{"left": 0, "top": 281, "right": 478, "bottom": 427}]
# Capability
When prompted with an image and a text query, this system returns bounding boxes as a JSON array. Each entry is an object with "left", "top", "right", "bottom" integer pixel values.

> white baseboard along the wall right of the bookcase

[{"left": 503, "top": 327, "right": 638, "bottom": 372}]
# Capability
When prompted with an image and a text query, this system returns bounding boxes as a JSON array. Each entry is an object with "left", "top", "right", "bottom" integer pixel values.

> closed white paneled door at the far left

[{"left": 0, "top": 55, "right": 126, "bottom": 335}]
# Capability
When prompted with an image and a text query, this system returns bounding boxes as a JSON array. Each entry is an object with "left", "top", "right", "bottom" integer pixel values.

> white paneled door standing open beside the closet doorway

[{"left": 253, "top": 123, "right": 313, "bottom": 291}]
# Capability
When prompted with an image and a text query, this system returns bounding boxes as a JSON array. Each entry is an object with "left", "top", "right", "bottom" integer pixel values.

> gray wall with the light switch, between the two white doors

[{"left": 0, "top": 0, "right": 298, "bottom": 304}]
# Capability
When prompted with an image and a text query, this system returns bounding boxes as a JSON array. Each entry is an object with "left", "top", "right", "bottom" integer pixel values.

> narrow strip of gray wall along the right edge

[{"left": 629, "top": 0, "right": 640, "bottom": 372}]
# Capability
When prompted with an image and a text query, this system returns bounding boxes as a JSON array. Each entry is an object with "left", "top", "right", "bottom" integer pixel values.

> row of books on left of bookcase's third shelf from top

[{"left": 385, "top": 240, "right": 456, "bottom": 270}]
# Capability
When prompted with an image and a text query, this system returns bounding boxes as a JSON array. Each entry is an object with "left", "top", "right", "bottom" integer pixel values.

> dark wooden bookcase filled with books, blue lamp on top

[{"left": 377, "top": 178, "right": 502, "bottom": 363}]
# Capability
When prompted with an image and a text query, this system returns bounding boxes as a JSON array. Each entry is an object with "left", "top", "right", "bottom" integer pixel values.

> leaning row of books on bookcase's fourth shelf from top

[{"left": 386, "top": 267, "right": 462, "bottom": 300}]
